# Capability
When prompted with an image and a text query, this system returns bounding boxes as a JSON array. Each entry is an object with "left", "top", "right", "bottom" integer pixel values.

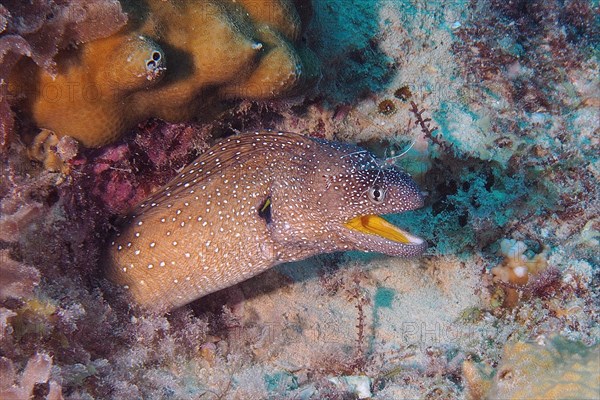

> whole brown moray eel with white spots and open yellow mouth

[{"left": 107, "top": 131, "right": 426, "bottom": 312}]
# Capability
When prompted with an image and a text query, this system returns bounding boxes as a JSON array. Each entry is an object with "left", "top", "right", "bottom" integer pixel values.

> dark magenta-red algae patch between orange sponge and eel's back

[{"left": 72, "top": 120, "right": 209, "bottom": 214}]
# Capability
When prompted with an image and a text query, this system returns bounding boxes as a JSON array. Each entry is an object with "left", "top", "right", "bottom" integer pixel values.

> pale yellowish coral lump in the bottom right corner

[{"left": 463, "top": 336, "right": 600, "bottom": 400}]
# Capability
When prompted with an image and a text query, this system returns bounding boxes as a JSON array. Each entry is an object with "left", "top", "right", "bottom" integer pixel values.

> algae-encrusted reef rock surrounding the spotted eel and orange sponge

[{"left": 0, "top": 0, "right": 600, "bottom": 400}]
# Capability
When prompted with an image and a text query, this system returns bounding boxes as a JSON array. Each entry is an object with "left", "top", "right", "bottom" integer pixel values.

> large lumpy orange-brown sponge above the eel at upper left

[{"left": 9, "top": 0, "right": 318, "bottom": 147}]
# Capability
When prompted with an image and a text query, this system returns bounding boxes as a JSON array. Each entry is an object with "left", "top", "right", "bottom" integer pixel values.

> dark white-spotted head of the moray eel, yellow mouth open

[{"left": 273, "top": 139, "right": 427, "bottom": 257}]
